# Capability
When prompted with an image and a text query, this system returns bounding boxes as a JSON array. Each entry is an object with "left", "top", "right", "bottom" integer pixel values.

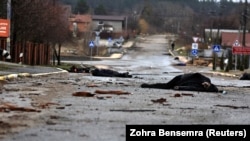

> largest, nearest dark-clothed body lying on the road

[{"left": 141, "top": 73, "right": 219, "bottom": 92}]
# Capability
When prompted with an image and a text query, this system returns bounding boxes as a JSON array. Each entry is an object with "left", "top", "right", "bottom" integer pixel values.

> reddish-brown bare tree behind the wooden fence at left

[{"left": 12, "top": 0, "right": 70, "bottom": 64}]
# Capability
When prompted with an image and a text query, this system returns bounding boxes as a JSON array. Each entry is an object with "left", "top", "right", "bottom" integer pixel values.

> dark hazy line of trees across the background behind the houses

[{"left": 58, "top": 0, "right": 244, "bottom": 34}]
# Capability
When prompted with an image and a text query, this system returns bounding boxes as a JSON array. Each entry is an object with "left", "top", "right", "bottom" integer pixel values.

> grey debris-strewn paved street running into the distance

[{"left": 0, "top": 35, "right": 250, "bottom": 141}]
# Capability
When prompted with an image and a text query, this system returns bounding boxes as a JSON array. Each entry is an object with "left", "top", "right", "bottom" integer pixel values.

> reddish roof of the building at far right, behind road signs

[{"left": 221, "top": 32, "right": 250, "bottom": 47}]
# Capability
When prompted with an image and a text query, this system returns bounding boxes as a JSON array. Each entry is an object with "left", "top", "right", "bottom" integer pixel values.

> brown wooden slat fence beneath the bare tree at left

[{"left": 0, "top": 39, "right": 51, "bottom": 65}]
